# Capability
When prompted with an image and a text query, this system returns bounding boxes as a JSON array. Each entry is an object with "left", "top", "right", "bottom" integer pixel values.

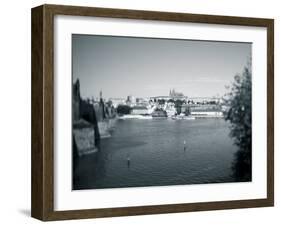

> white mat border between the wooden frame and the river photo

[{"left": 54, "top": 16, "right": 267, "bottom": 210}]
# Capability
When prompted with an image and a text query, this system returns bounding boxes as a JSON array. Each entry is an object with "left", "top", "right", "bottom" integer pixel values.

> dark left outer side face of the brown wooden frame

[{"left": 31, "top": 6, "right": 44, "bottom": 220}]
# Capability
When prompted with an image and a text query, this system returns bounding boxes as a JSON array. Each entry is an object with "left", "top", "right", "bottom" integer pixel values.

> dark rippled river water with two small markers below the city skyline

[{"left": 73, "top": 118, "right": 237, "bottom": 189}]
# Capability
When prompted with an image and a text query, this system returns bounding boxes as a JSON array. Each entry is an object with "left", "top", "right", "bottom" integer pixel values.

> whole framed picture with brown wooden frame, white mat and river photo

[{"left": 31, "top": 5, "right": 274, "bottom": 221}]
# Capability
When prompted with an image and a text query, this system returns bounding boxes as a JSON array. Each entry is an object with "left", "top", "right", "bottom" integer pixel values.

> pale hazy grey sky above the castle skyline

[{"left": 72, "top": 34, "right": 251, "bottom": 98}]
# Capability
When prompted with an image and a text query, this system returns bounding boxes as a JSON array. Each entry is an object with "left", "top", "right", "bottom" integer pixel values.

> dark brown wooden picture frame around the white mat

[{"left": 31, "top": 5, "right": 274, "bottom": 221}]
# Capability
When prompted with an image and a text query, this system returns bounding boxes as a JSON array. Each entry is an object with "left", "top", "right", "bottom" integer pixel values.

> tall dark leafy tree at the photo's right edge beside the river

[{"left": 224, "top": 64, "right": 252, "bottom": 181}]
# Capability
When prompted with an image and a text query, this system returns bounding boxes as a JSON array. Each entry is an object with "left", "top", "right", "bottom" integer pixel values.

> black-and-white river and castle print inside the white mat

[{"left": 72, "top": 34, "right": 252, "bottom": 190}]
